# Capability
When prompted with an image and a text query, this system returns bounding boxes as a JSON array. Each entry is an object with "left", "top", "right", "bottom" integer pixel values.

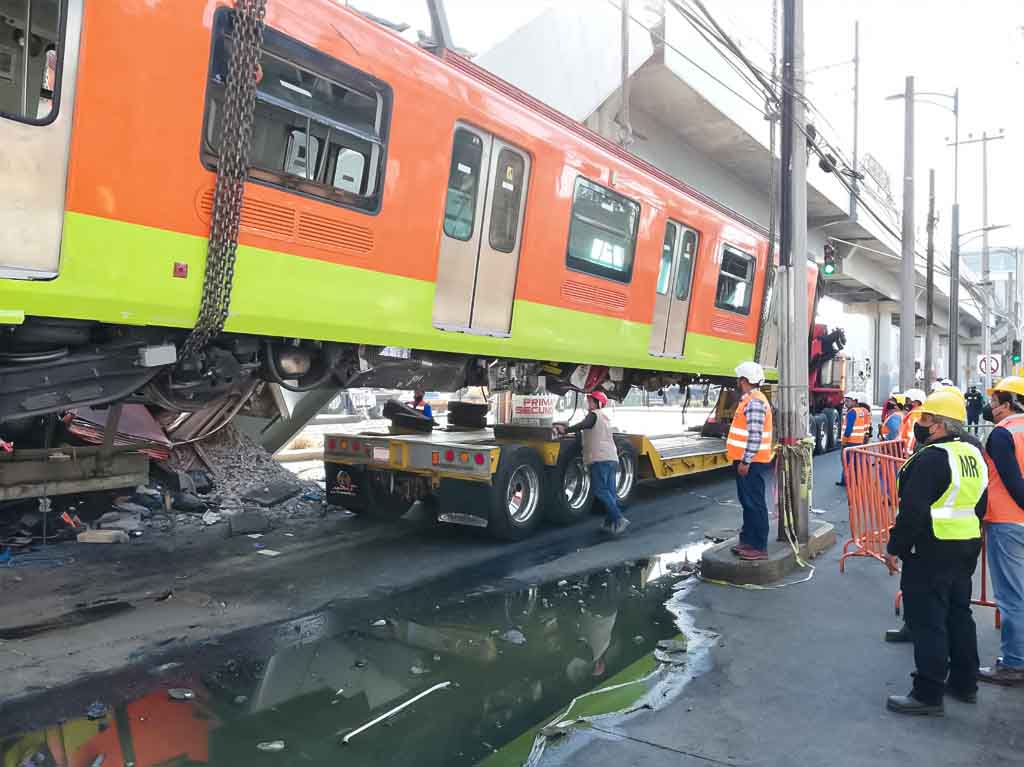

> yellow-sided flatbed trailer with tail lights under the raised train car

[{"left": 324, "top": 418, "right": 729, "bottom": 541}]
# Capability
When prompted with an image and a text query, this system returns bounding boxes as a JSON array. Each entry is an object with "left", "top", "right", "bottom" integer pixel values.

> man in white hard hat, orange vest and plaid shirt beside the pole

[{"left": 725, "top": 363, "right": 774, "bottom": 560}]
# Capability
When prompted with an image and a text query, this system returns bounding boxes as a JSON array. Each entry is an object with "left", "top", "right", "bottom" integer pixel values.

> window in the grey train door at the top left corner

[{"left": 0, "top": 0, "right": 68, "bottom": 125}]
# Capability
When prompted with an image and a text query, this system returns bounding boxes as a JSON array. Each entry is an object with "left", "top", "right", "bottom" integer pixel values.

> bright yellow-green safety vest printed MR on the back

[{"left": 896, "top": 439, "right": 988, "bottom": 541}]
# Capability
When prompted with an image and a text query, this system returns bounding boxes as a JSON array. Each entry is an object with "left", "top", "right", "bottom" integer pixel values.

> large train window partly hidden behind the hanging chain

[{"left": 203, "top": 8, "right": 391, "bottom": 213}]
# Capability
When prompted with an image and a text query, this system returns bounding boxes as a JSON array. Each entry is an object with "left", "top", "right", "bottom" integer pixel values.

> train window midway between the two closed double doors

[{"left": 566, "top": 177, "right": 640, "bottom": 283}]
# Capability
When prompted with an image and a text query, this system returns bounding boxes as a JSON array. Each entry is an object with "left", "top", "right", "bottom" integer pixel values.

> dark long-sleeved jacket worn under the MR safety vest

[{"left": 888, "top": 437, "right": 987, "bottom": 580}]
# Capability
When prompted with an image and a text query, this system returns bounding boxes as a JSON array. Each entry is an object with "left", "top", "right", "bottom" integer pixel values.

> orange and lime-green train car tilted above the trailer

[{"left": 0, "top": 0, "right": 774, "bottom": 422}]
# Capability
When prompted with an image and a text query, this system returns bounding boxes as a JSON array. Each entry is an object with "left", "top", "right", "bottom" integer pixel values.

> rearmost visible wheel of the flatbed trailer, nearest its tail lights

[{"left": 487, "top": 446, "right": 545, "bottom": 541}]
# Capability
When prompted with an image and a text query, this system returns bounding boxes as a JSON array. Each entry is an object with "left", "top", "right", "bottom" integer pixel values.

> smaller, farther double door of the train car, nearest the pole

[{"left": 648, "top": 219, "right": 699, "bottom": 357}]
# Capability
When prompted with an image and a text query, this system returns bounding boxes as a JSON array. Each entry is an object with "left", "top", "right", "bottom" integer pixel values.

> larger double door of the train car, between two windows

[{"left": 433, "top": 124, "right": 529, "bottom": 336}]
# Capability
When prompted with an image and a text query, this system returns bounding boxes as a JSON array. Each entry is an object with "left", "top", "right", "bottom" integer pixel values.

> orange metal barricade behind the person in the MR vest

[{"left": 839, "top": 439, "right": 906, "bottom": 572}]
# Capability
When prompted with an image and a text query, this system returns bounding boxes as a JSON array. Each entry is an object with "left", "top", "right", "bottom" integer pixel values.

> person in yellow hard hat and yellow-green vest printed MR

[{"left": 886, "top": 390, "right": 988, "bottom": 716}]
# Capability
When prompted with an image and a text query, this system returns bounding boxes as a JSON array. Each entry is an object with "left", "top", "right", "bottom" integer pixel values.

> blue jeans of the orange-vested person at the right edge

[{"left": 985, "top": 522, "right": 1024, "bottom": 669}]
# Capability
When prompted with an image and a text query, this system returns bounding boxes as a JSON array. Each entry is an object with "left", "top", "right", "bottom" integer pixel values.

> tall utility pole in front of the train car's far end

[{"left": 778, "top": 0, "right": 812, "bottom": 543}]
